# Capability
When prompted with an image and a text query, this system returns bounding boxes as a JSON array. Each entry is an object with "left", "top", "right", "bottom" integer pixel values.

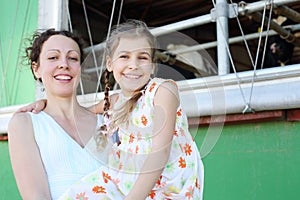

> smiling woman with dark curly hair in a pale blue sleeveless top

[{"left": 8, "top": 29, "right": 102, "bottom": 200}]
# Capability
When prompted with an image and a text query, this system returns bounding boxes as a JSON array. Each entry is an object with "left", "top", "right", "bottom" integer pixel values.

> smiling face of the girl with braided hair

[{"left": 106, "top": 37, "right": 154, "bottom": 96}]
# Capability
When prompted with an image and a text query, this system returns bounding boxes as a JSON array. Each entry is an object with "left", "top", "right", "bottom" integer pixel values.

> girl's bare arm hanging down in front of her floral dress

[{"left": 126, "top": 82, "right": 179, "bottom": 200}]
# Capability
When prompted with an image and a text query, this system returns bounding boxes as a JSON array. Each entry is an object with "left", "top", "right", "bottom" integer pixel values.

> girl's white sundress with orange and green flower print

[{"left": 61, "top": 78, "right": 204, "bottom": 200}]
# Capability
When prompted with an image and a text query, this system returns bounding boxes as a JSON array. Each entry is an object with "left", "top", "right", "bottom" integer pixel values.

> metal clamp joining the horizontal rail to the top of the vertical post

[{"left": 210, "top": 3, "right": 238, "bottom": 22}]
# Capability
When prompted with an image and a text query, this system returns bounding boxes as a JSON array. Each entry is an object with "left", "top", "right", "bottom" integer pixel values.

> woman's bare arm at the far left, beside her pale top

[{"left": 8, "top": 113, "right": 51, "bottom": 200}]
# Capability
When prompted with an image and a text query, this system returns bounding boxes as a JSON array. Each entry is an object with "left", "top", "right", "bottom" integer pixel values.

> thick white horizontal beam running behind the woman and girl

[{"left": 0, "top": 64, "right": 300, "bottom": 133}]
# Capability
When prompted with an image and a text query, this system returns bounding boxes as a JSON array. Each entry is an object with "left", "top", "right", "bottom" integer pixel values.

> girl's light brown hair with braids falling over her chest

[{"left": 96, "top": 20, "right": 158, "bottom": 150}]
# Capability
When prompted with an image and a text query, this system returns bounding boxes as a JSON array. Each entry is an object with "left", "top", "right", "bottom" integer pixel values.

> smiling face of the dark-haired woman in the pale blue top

[{"left": 32, "top": 35, "right": 81, "bottom": 96}]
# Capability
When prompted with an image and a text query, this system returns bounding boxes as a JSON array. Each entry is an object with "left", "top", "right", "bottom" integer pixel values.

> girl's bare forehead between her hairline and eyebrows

[{"left": 116, "top": 37, "right": 151, "bottom": 52}]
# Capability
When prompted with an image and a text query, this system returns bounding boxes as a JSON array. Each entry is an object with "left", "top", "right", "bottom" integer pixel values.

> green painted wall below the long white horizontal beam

[{"left": 0, "top": 121, "right": 300, "bottom": 200}]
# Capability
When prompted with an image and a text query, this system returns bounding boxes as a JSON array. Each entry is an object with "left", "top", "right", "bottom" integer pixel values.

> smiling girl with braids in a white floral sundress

[{"left": 21, "top": 21, "right": 204, "bottom": 200}]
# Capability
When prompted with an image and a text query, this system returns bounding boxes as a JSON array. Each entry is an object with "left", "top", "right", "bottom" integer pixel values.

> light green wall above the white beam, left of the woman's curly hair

[{"left": 0, "top": 0, "right": 38, "bottom": 107}]
